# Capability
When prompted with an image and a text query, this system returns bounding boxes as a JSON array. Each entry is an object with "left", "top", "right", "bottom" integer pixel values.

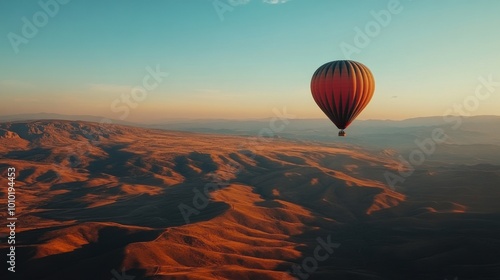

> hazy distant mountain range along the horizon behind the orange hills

[{"left": 0, "top": 113, "right": 500, "bottom": 152}]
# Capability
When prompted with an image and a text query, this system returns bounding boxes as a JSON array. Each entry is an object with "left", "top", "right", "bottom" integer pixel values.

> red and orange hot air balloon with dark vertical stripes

[{"left": 311, "top": 60, "right": 375, "bottom": 136}]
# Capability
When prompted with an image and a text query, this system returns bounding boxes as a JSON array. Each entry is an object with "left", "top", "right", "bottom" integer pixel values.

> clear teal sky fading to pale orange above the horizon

[{"left": 0, "top": 0, "right": 500, "bottom": 121}]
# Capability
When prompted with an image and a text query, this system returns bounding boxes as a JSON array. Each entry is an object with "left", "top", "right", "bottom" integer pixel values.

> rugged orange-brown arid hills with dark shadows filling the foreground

[{"left": 0, "top": 120, "right": 500, "bottom": 280}]
